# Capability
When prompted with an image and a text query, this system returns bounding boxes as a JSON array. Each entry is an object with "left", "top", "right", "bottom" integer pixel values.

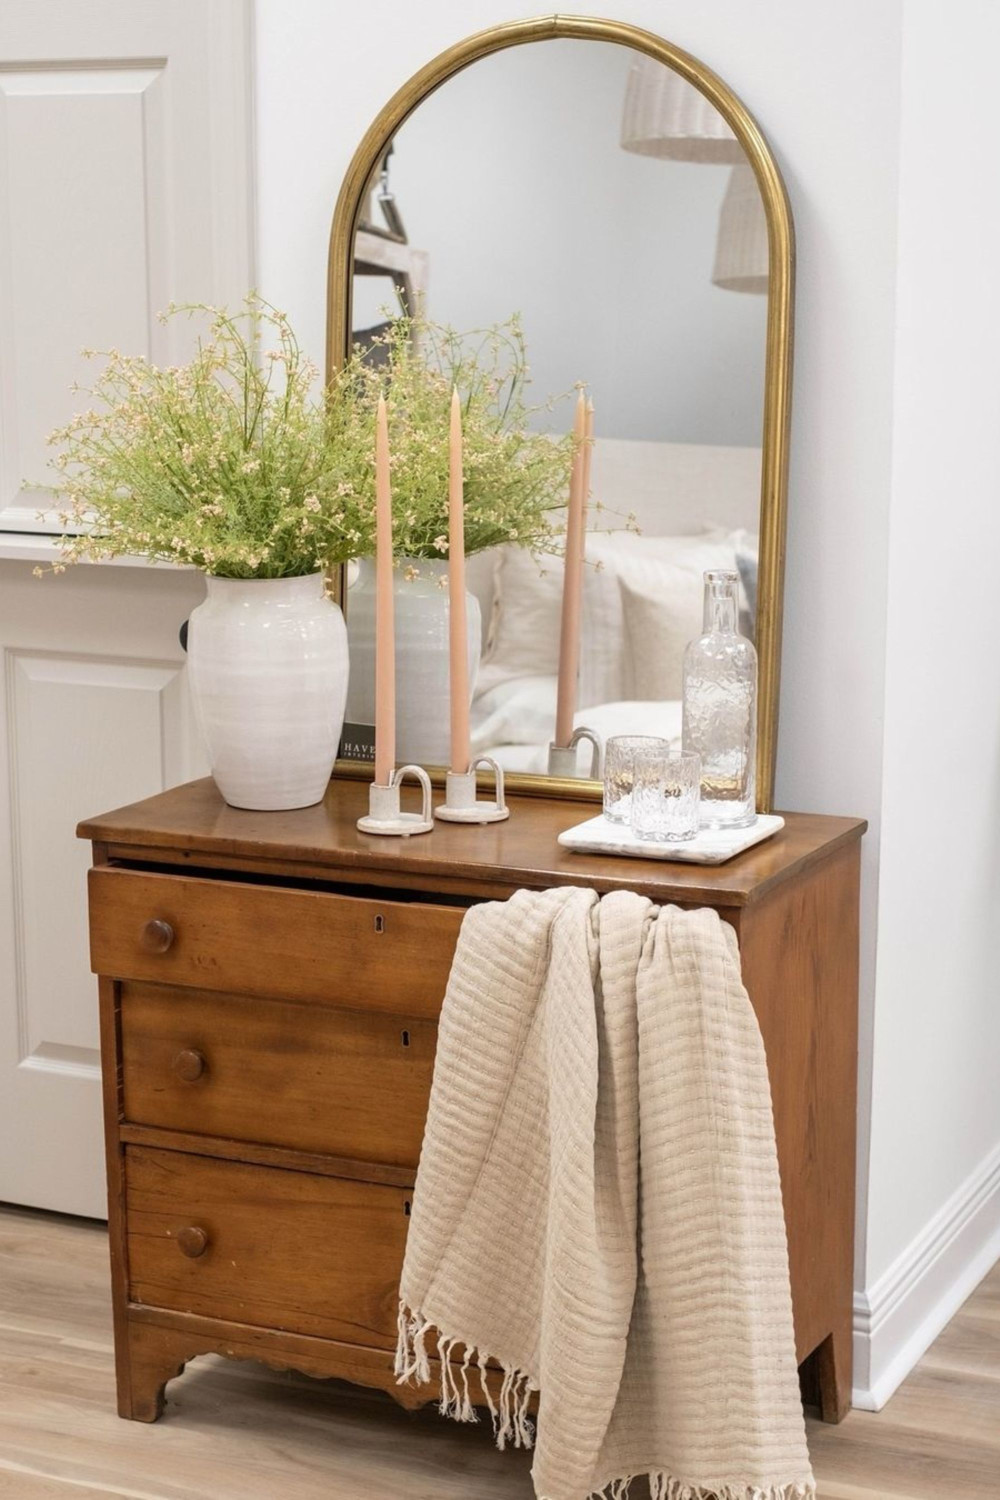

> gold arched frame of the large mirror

[{"left": 327, "top": 15, "right": 795, "bottom": 813}]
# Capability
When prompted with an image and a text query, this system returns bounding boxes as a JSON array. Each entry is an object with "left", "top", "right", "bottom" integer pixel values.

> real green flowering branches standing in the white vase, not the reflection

[{"left": 36, "top": 293, "right": 375, "bottom": 579}]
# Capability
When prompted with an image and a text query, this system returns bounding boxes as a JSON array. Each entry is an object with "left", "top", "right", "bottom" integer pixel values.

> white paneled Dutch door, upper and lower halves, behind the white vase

[{"left": 0, "top": 0, "right": 252, "bottom": 1215}]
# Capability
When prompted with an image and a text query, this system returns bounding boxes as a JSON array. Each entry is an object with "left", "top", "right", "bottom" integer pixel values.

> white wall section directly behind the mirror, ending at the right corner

[{"left": 256, "top": 0, "right": 900, "bottom": 1056}]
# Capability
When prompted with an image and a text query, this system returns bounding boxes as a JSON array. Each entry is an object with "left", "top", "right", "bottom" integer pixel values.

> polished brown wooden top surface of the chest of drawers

[{"left": 78, "top": 779, "right": 867, "bottom": 906}]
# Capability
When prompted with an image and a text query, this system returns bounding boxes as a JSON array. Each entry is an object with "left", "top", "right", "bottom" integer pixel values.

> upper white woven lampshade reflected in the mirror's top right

[{"left": 622, "top": 57, "right": 747, "bottom": 164}]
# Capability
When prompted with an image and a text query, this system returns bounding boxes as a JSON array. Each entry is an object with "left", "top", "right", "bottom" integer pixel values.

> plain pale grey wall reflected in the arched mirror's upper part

[{"left": 355, "top": 39, "right": 768, "bottom": 447}]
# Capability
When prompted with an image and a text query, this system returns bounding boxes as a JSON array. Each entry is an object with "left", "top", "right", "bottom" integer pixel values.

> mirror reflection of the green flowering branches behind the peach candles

[{"left": 328, "top": 317, "right": 573, "bottom": 558}]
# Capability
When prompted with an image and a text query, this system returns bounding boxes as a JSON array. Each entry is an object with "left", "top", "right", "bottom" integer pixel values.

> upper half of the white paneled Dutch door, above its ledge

[{"left": 0, "top": 0, "right": 252, "bottom": 531}]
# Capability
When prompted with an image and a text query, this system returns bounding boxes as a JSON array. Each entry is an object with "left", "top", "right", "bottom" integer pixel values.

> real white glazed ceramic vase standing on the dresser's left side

[{"left": 187, "top": 573, "right": 348, "bottom": 812}]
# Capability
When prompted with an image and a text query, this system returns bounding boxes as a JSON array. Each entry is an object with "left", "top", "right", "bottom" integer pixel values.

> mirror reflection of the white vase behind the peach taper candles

[{"left": 348, "top": 558, "right": 483, "bottom": 765}]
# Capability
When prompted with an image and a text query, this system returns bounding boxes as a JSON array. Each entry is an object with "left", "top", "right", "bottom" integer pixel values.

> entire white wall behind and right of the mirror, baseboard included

[{"left": 258, "top": 0, "right": 1000, "bottom": 1398}]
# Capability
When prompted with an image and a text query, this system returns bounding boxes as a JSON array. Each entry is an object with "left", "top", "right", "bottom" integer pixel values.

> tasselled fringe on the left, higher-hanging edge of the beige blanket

[{"left": 394, "top": 1302, "right": 539, "bottom": 1452}]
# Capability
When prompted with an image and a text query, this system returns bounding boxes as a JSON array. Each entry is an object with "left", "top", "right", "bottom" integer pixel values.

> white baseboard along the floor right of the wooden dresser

[{"left": 852, "top": 1146, "right": 1000, "bottom": 1412}]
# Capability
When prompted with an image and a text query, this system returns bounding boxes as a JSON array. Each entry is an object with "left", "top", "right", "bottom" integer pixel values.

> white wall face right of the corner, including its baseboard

[{"left": 862, "top": 0, "right": 1000, "bottom": 1404}]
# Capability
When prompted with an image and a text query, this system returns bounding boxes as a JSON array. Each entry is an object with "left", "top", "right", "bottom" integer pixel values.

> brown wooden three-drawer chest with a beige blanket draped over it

[{"left": 79, "top": 782, "right": 864, "bottom": 1421}]
